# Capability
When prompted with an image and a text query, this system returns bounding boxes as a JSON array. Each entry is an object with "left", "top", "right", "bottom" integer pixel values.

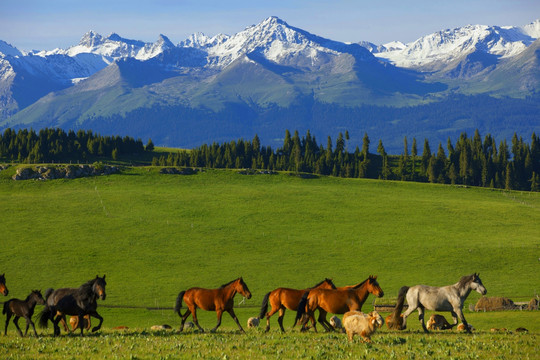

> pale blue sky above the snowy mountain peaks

[{"left": 0, "top": 0, "right": 540, "bottom": 50}]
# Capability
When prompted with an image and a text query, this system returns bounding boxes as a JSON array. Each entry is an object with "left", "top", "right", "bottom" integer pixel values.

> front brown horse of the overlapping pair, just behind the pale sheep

[{"left": 296, "top": 275, "right": 384, "bottom": 331}]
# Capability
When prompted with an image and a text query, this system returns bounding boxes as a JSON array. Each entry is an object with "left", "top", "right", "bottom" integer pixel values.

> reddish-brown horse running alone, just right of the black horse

[{"left": 174, "top": 277, "right": 251, "bottom": 332}]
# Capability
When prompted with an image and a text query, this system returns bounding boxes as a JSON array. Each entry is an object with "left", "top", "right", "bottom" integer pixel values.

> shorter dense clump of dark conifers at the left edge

[{"left": 0, "top": 128, "right": 144, "bottom": 163}]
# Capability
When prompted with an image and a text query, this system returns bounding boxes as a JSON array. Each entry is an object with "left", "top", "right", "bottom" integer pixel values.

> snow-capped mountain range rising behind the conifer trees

[{"left": 0, "top": 17, "right": 540, "bottom": 150}]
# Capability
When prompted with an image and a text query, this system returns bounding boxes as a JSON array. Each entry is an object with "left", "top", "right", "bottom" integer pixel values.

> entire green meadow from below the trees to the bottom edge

[{"left": 0, "top": 167, "right": 540, "bottom": 359}]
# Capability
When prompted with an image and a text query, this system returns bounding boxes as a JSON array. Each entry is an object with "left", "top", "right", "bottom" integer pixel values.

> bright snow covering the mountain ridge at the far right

[{"left": 375, "top": 21, "right": 540, "bottom": 68}]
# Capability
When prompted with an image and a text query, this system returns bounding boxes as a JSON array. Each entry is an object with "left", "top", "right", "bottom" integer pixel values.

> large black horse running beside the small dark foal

[{"left": 39, "top": 275, "right": 107, "bottom": 336}]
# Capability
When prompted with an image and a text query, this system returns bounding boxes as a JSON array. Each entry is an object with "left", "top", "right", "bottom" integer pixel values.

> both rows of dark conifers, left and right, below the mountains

[{"left": 0, "top": 129, "right": 540, "bottom": 191}]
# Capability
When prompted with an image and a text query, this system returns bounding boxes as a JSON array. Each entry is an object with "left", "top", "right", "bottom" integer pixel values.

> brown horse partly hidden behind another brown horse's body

[{"left": 259, "top": 278, "right": 336, "bottom": 332}]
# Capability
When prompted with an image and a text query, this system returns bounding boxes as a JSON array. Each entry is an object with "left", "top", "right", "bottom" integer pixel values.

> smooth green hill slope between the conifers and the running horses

[{"left": 0, "top": 168, "right": 540, "bottom": 328}]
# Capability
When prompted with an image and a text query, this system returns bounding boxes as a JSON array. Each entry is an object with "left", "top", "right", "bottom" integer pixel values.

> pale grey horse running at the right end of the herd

[{"left": 394, "top": 273, "right": 487, "bottom": 332}]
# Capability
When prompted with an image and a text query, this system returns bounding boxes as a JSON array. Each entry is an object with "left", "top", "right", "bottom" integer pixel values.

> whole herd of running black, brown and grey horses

[{"left": 0, "top": 273, "right": 487, "bottom": 336}]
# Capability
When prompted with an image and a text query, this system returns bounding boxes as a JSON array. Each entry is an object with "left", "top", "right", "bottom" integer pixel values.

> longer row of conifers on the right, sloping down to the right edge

[{"left": 152, "top": 130, "right": 540, "bottom": 191}]
